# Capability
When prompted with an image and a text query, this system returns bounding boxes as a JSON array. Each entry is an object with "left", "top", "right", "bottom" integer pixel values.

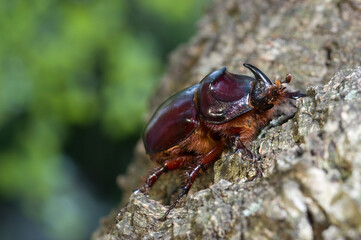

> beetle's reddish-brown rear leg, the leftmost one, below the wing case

[{"left": 134, "top": 156, "right": 192, "bottom": 193}]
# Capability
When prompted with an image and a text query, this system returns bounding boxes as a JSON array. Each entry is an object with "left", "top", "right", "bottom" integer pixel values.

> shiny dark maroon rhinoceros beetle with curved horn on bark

[{"left": 138, "top": 63, "right": 304, "bottom": 220}]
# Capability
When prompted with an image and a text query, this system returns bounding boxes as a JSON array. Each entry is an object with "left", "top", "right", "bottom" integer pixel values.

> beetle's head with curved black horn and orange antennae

[{"left": 243, "top": 63, "right": 304, "bottom": 111}]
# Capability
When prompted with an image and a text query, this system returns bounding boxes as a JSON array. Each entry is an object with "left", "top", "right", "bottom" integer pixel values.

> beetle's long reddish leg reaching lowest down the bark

[{"left": 160, "top": 143, "right": 224, "bottom": 221}]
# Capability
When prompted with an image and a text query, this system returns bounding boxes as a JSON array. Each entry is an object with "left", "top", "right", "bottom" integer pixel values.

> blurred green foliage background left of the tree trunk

[{"left": 0, "top": 0, "right": 209, "bottom": 240}]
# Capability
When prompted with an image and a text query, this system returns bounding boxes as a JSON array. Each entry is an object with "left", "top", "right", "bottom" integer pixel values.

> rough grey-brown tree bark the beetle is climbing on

[{"left": 93, "top": 0, "right": 361, "bottom": 239}]
